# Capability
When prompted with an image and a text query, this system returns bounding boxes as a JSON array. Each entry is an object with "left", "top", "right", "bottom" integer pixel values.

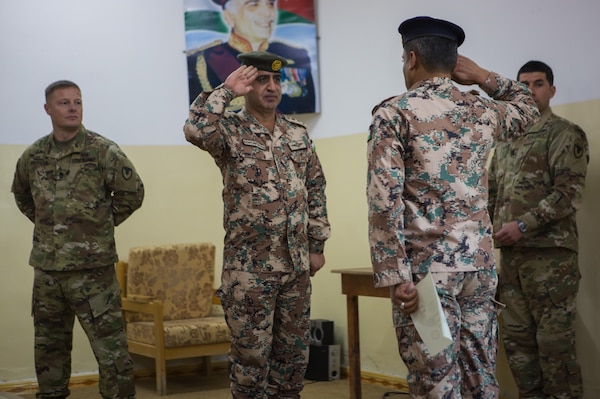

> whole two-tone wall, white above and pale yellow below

[{"left": 0, "top": 0, "right": 600, "bottom": 398}]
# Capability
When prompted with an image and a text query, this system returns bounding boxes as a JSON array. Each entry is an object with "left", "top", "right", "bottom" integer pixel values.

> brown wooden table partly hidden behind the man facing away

[{"left": 332, "top": 268, "right": 391, "bottom": 399}]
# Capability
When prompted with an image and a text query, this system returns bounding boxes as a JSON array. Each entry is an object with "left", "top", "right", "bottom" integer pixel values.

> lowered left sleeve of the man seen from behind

[{"left": 367, "top": 107, "right": 412, "bottom": 287}]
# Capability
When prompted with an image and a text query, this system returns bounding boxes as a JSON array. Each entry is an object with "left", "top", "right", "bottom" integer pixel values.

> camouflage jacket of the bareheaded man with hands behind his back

[{"left": 12, "top": 127, "right": 144, "bottom": 271}]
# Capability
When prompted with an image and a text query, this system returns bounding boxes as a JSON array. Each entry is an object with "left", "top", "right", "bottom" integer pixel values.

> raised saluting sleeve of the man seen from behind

[{"left": 480, "top": 72, "right": 540, "bottom": 139}]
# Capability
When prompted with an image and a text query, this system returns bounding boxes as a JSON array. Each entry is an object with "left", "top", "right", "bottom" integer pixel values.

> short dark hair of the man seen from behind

[{"left": 404, "top": 36, "right": 458, "bottom": 72}]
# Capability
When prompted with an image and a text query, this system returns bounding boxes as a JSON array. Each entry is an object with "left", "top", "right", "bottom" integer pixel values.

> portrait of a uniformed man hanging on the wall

[{"left": 183, "top": 0, "right": 320, "bottom": 114}]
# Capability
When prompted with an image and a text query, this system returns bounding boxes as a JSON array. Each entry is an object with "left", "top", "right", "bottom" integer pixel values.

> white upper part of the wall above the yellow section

[{"left": 0, "top": 0, "right": 600, "bottom": 145}]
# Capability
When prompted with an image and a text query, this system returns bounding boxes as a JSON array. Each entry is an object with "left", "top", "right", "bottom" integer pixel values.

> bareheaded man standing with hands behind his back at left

[{"left": 12, "top": 81, "right": 144, "bottom": 398}]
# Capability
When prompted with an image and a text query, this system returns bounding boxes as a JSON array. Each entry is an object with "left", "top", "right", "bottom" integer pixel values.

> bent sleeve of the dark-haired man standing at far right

[{"left": 520, "top": 124, "right": 589, "bottom": 233}]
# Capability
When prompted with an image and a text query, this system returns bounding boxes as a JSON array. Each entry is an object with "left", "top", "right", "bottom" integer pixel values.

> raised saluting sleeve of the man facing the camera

[{"left": 183, "top": 85, "right": 235, "bottom": 163}]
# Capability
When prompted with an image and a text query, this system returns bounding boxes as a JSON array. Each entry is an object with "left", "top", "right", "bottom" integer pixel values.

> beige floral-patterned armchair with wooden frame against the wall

[{"left": 116, "top": 243, "right": 230, "bottom": 395}]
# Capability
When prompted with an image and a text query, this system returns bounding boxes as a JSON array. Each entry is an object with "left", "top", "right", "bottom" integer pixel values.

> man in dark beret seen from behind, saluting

[{"left": 367, "top": 17, "right": 538, "bottom": 398}]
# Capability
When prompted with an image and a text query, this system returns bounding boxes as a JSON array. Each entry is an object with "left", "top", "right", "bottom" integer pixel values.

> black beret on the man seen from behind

[{"left": 398, "top": 17, "right": 465, "bottom": 47}]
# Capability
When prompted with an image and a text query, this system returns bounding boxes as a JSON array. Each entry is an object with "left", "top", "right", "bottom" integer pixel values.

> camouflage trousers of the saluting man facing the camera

[{"left": 217, "top": 270, "right": 311, "bottom": 399}]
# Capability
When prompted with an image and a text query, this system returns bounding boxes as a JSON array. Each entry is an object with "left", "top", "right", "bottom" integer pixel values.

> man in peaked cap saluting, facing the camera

[{"left": 184, "top": 51, "right": 330, "bottom": 399}]
